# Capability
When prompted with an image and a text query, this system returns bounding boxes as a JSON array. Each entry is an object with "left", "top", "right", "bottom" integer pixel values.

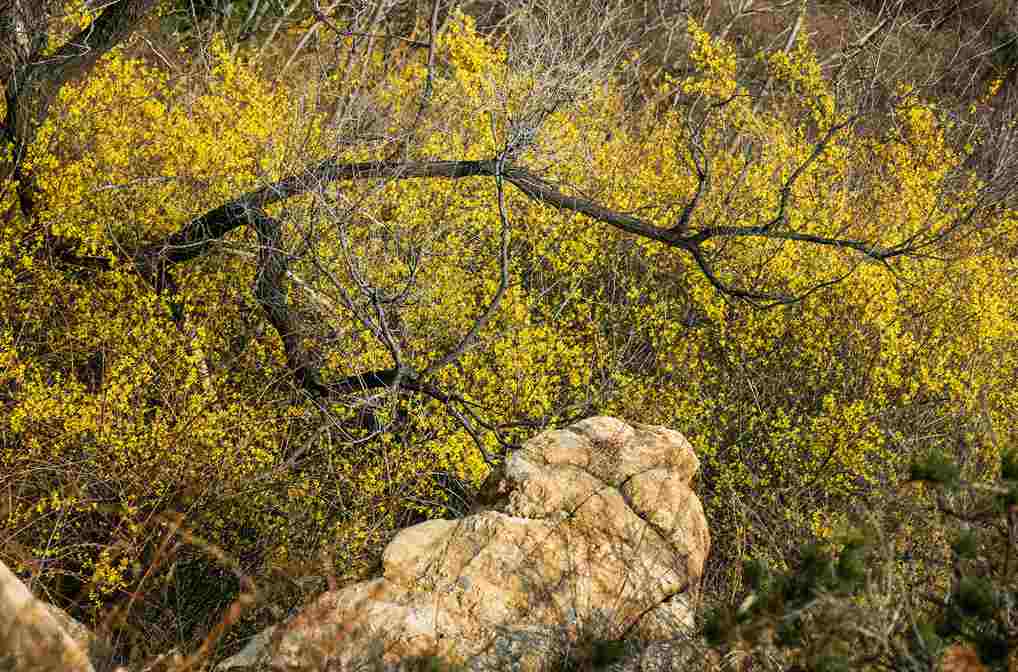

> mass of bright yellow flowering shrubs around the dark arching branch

[{"left": 0, "top": 10, "right": 1018, "bottom": 631}]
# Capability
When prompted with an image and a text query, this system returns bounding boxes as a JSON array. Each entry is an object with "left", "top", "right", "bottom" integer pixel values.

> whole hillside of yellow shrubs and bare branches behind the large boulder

[{"left": 0, "top": 0, "right": 1018, "bottom": 659}]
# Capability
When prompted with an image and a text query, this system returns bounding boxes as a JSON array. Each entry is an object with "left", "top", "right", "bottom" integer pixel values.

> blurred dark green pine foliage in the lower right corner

[{"left": 701, "top": 445, "right": 1018, "bottom": 672}]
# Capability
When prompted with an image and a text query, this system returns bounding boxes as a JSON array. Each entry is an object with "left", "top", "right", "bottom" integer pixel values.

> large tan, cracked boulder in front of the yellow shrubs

[{"left": 218, "top": 417, "right": 710, "bottom": 672}]
